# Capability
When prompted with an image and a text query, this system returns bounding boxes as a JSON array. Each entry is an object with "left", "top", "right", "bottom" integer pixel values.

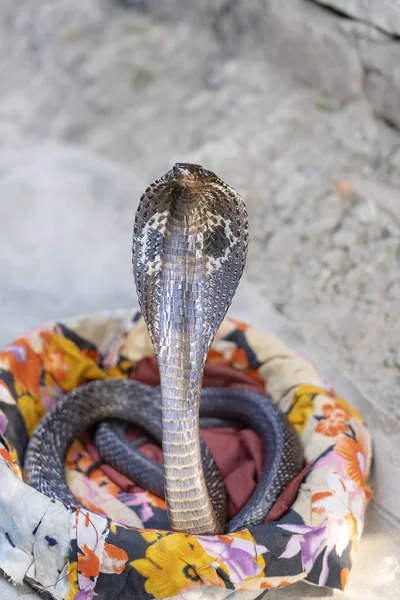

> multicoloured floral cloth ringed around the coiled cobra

[{"left": 0, "top": 311, "right": 371, "bottom": 600}]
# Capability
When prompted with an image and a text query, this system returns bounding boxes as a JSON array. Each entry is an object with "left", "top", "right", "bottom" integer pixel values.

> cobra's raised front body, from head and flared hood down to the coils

[{"left": 133, "top": 163, "right": 249, "bottom": 534}]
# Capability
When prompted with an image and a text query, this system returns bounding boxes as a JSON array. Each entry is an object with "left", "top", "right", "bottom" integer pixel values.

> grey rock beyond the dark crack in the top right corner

[{"left": 316, "top": 0, "right": 400, "bottom": 35}]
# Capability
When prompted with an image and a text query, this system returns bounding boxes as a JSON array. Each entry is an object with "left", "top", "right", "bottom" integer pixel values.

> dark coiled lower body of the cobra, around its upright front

[{"left": 25, "top": 379, "right": 302, "bottom": 533}]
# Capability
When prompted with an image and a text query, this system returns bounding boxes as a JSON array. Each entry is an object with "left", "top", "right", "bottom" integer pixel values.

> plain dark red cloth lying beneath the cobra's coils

[{"left": 85, "top": 357, "right": 304, "bottom": 521}]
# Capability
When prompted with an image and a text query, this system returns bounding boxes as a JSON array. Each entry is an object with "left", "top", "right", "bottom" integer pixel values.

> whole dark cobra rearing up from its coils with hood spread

[{"left": 24, "top": 163, "right": 303, "bottom": 535}]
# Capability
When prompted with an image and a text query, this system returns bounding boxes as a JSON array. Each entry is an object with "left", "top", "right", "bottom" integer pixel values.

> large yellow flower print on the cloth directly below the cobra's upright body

[{"left": 130, "top": 532, "right": 221, "bottom": 598}]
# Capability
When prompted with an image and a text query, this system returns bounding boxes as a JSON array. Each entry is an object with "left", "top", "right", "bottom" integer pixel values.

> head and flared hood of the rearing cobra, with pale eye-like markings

[{"left": 133, "top": 163, "right": 249, "bottom": 352}]
